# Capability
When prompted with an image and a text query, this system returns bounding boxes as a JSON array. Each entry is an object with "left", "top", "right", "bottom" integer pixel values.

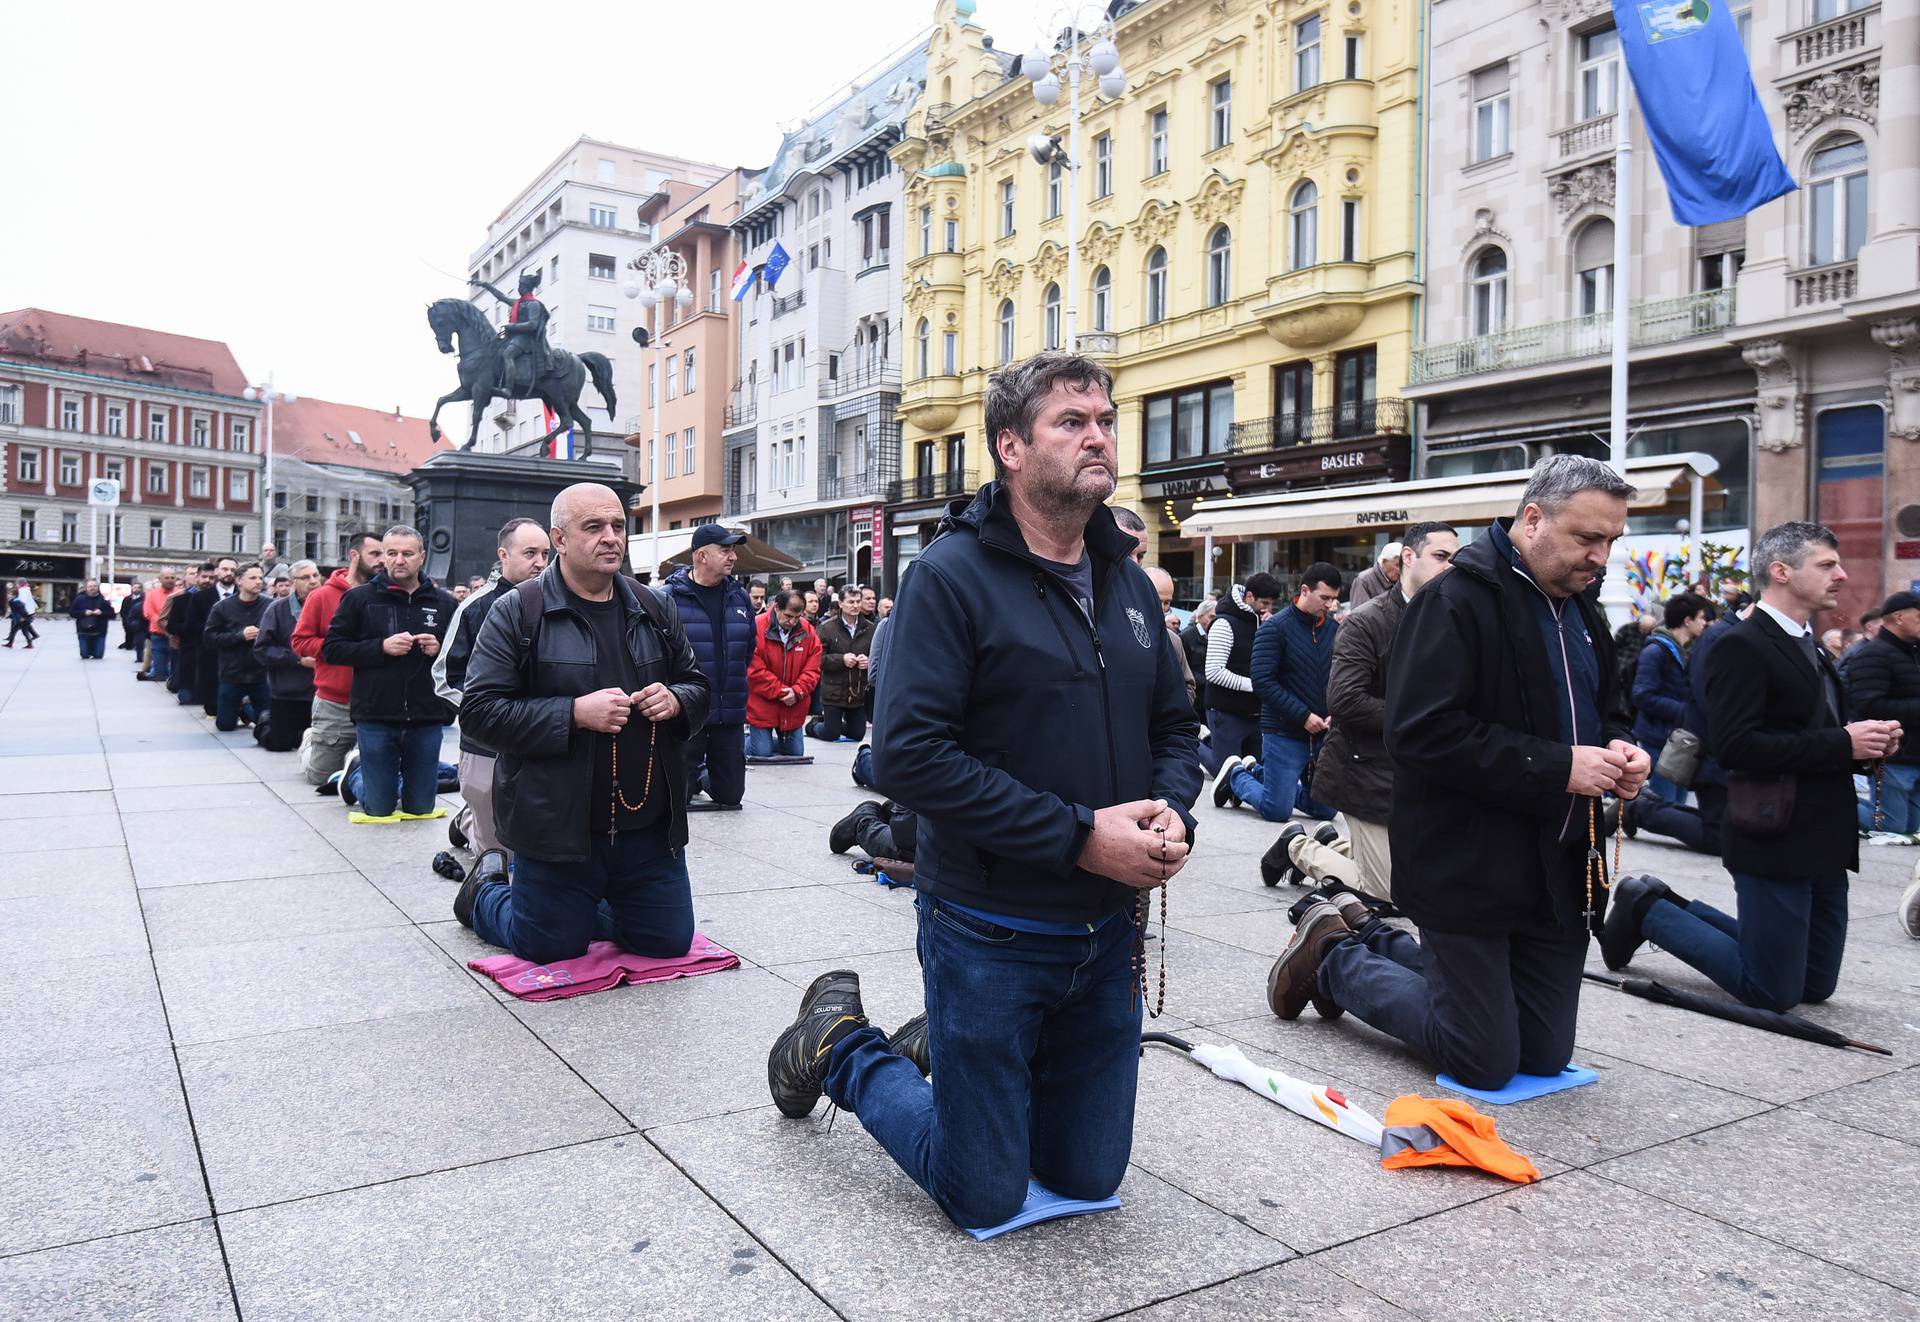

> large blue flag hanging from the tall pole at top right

[{"left": 1613, "top": 0, "right": 1795, "bottom": 224}]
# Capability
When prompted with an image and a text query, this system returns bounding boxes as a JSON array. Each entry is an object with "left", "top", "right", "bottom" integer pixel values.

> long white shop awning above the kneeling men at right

[{"left": 1181, "top": 453, "right": 1718, "bottom": 541}]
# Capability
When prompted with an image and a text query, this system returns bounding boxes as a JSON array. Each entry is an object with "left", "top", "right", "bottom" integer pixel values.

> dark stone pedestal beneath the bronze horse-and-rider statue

[{"left": 405, "top": 451, "right": 645, "bottom": 583}]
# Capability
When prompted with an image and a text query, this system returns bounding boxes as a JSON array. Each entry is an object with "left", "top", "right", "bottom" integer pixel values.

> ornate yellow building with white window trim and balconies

[{"left": 889, "top": 0, "right": 1421, "bottom": 597}]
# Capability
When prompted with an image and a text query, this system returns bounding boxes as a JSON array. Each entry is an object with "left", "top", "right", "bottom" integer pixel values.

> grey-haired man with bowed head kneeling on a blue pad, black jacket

[{"left": 1267, "top": 455, "right": 1651, "bottom": 1088}]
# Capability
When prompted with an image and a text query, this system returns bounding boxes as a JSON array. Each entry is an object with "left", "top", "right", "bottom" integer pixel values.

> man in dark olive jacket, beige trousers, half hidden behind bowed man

[{"left": 1313, "top": 522, "right": 1459, "bottom": 900}]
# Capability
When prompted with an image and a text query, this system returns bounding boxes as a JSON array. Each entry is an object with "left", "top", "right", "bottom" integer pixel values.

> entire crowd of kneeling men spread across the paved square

[{"left": 48, "top": 353, "right": 1920, "bottom": 1228}]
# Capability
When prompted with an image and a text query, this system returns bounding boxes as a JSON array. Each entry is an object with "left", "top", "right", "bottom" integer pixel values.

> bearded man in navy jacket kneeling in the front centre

[{"left": 768, "top": 353, "right": 1200, "bottom": 1228}]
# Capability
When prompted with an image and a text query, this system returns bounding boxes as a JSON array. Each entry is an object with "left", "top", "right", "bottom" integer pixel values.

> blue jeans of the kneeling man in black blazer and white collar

[{"left": 1642, "top": 871, "right": 1847, "bottom": 1009}]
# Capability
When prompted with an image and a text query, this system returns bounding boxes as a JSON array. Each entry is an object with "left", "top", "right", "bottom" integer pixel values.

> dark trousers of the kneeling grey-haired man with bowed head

[{"left": 1319, "top": 923, "right": 1586, "bottom": 1088}]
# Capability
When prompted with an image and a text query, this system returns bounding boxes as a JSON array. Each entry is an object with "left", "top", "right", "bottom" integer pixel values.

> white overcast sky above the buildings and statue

[{"left": 0, "top": 0, "right": 1059, "bottom": 414}]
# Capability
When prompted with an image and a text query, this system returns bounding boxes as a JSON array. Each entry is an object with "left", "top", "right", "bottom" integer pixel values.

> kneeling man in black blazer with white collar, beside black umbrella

[{"left": 1599, "top": 524, "right": 1903, "bottom": 1009}]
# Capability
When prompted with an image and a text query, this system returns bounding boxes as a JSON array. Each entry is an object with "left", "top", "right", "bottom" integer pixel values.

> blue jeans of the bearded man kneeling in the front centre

[{"left": 826, "top": 896, "right": 1140, "bottom": 1228}]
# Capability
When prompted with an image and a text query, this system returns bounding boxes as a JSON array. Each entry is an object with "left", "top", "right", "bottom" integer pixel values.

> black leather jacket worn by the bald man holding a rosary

[{"left": 461, "top": 564, "right": 708, "bottom": 862}]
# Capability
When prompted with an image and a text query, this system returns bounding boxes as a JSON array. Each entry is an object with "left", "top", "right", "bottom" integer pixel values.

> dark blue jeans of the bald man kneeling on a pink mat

[{"left": 474, "top": 821, "right": 695, "bottom": 959}]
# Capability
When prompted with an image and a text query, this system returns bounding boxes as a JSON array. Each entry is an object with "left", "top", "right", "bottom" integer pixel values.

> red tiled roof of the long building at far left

[{"left": 0, "top": 307, "right": 248, "bottom": 395}]
